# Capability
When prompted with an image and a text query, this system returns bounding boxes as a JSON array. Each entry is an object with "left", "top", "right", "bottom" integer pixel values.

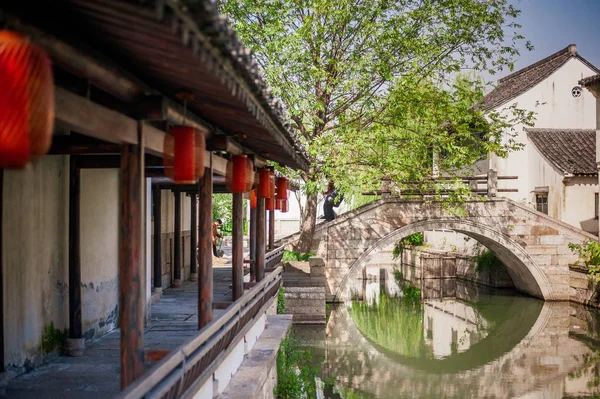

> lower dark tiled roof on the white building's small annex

[{"left": 525, "top": 128, "right": 597, "bottom": 175}]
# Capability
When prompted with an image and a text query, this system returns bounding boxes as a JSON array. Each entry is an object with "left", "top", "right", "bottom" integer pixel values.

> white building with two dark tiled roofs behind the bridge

[{"left": 484, "top": 44, "right": 600, "bottom": 234}]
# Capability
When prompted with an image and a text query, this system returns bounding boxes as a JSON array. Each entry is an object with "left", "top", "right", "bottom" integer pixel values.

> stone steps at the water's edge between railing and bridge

[{"left": 283, "top": 258, "right": 327, "bottom": 324}]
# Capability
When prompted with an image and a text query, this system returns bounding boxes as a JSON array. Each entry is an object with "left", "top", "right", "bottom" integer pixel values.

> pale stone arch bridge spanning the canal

[{"left": 296, "top": 198, "right": 597, "bottom": 301}]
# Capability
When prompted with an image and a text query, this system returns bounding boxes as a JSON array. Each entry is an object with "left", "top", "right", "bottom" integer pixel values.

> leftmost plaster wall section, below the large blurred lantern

[{"left": 2, "top": 156, "right": 69, "bottom": 370}]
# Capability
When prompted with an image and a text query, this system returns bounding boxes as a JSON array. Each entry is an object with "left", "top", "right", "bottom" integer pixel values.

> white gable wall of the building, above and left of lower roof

[{"left": 496, "top": 58, "right": 596, "bottom": 202}]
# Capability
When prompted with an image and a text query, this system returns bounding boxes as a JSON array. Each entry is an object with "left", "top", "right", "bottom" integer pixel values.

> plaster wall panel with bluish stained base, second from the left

[{"left": 80, "top": 169, "right": 119, "bottom": 339}]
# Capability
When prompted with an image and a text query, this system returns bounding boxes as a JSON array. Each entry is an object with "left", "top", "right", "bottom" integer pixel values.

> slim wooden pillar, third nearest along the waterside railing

[{"left": 231, "top": 193, "right": 244, "bottom": 301}]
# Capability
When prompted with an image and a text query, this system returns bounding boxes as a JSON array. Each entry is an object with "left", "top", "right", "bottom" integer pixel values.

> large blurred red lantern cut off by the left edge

[{"left": 0, "top": 31, "right": 54, "bottom": 169}]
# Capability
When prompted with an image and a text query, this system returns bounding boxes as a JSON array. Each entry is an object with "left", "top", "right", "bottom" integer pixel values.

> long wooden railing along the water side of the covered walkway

[{"left": 117, "top": 262, "right": 283, "bottom": 399}]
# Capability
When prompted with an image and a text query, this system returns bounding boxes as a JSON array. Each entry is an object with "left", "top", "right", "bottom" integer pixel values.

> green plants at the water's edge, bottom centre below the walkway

[{"left": 273, "top": 335, "right": 320, "bottom": 399}]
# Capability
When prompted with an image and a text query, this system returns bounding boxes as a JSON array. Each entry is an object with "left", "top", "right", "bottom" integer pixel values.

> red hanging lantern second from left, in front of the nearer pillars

[{"left": 163, "top": 126, "right": 205, "bottom": 184}]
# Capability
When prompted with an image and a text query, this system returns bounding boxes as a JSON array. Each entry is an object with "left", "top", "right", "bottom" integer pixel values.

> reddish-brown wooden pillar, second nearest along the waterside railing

[{"left": 198, "top": 167, "right": 213, "bottom": 329}]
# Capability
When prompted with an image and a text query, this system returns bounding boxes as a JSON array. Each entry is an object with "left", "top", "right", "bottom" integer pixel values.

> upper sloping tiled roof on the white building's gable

[{"left": 483, "top": 44, "right": 600, "bottom": 109}]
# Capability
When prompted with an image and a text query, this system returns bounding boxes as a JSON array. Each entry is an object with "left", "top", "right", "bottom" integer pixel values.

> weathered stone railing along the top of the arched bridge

[{"left": 363, "top": 170, "right": 519, "bottom": 198}]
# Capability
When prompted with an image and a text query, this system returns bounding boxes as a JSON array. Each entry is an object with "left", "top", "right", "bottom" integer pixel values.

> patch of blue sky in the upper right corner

[{"left": 491, "top": 0, "right": 600, "bottom": 80}]
